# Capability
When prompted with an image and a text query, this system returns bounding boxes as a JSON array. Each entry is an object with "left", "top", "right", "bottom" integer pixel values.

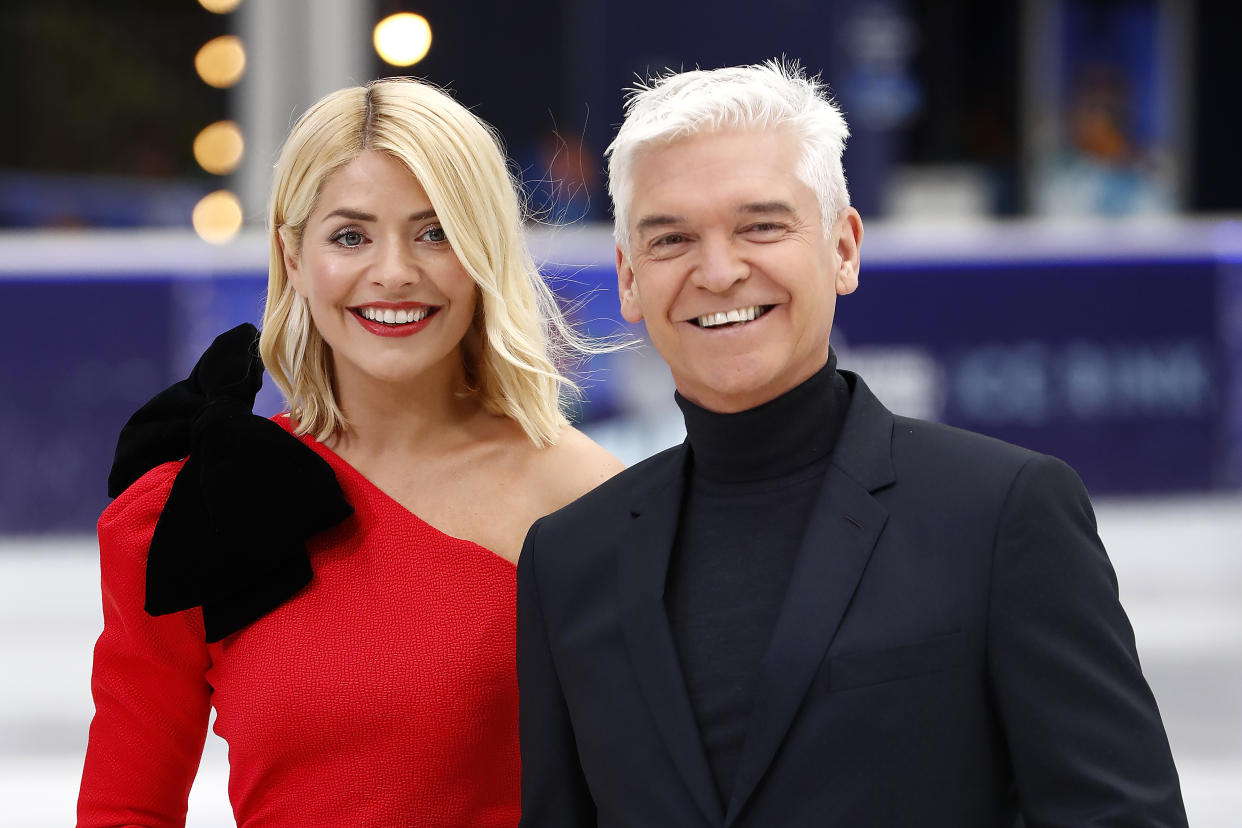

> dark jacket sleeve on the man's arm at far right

[{"left": 987, "top": 456, "right": 1186, "bottom": 828}]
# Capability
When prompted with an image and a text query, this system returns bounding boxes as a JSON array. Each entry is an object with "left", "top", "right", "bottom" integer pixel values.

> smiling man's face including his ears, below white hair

[{"left": 617, "top": 130, "right": 862, "bottom": 412}]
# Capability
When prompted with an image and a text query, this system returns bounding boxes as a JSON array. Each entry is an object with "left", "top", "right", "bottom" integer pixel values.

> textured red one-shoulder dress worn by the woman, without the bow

[{"left": 78, "top": 417, "right": 519, "bottom": 828}]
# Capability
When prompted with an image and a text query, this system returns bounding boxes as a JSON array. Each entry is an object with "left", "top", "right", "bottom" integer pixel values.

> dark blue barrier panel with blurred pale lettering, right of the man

[{"left": 833, "top": 258, "right": 1227, "bottom": 492}]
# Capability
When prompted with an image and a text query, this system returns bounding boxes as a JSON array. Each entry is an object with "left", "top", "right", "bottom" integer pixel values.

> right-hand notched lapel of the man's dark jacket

[{"left": 724, "top": 371, "right": 894, "bottom": 826}]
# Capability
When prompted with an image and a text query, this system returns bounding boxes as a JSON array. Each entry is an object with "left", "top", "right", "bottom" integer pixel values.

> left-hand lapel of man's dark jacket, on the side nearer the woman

[{"left": 617, "top": 444, "right": 723, "bottom": 826}]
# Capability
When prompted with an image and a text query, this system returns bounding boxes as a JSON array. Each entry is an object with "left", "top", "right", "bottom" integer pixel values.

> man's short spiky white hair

[{"left": 605, "top": 58, "right": 850, "bottom": 251}]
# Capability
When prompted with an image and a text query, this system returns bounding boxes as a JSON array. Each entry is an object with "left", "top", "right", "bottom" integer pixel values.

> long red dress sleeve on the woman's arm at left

[{"left": 77, "top": 463, "right": 211, "bottom": 828}]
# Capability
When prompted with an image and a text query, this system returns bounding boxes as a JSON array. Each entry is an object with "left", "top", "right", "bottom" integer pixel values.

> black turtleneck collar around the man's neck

[{"left": 674, "top": 350, "right": 850, "bottom": 483}]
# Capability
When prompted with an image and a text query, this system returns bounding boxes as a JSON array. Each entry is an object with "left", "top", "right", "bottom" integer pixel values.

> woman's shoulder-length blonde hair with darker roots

[{"left": 260, "top": 78, "right": 583, "bottom": 446}]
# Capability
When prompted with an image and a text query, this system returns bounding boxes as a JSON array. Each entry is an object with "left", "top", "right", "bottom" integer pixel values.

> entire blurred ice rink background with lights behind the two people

[{"left": 0, "top": 0, "right": 1242, "bottom": 827}]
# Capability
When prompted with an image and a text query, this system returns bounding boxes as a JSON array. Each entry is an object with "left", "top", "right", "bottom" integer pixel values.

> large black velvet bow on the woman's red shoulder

[{"left": 108, "top": 324, "right": 354, "bottom": 642}]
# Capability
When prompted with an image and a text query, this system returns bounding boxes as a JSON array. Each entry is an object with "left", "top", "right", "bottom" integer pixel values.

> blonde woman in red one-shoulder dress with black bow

[{"left": 78, "top": 79, "right": 620, "bottom": 826}]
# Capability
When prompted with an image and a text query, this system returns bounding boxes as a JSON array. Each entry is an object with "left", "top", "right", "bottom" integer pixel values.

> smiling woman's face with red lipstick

[{"left": 284, "top": 150, "right": 477, "bottom": 407}]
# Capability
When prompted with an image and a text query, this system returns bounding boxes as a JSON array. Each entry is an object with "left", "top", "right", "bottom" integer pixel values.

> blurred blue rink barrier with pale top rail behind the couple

[{"left": 7, "top": 222, "right": 1242, "bottom": 533}]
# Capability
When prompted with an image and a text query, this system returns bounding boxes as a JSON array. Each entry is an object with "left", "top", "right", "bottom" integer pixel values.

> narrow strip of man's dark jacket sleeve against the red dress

[{"left": 518, "top": 521, "right": 596, "bottom": 828}]
